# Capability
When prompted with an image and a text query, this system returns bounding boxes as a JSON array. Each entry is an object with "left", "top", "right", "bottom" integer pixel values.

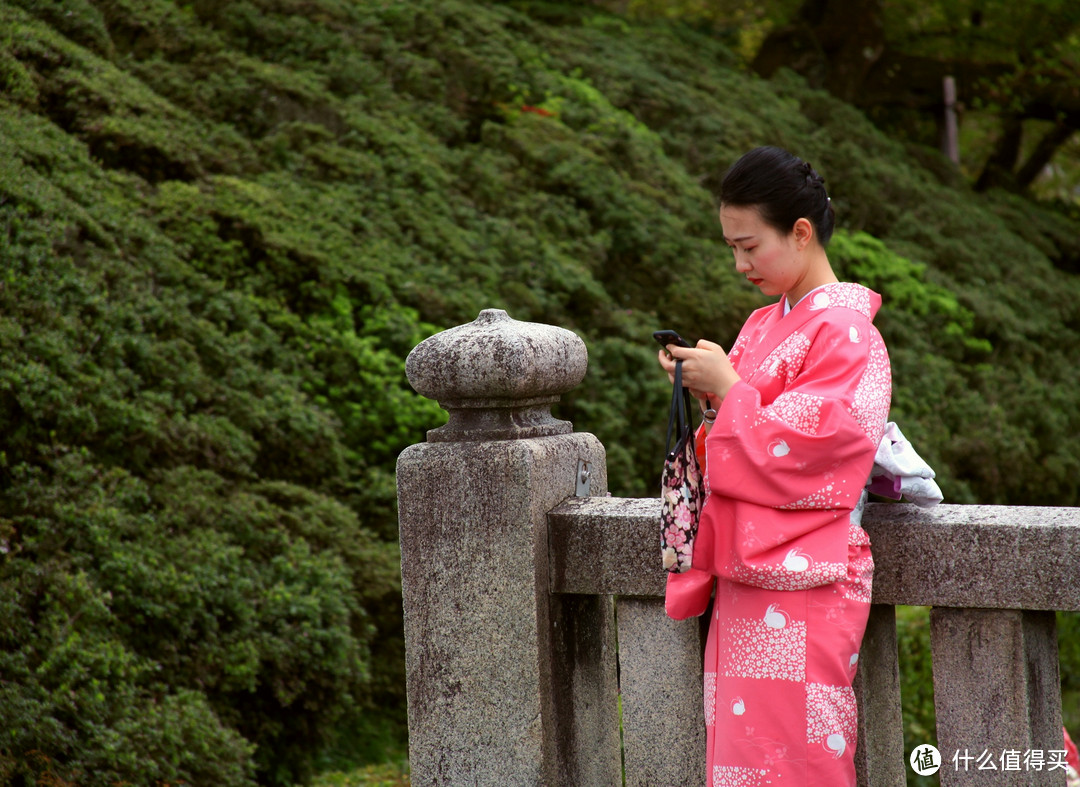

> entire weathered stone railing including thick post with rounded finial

[{"left": 397, "top": 310, "right": 1080, "bottom": 787}]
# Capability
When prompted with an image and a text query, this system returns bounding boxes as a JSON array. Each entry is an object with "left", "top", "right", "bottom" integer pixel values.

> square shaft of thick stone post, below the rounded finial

[{"left": 397, "top": 434, "right": 618, "bottom": 787}]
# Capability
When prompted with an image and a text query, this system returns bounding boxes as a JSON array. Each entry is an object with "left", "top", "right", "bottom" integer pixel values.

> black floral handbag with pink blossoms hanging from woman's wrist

[{"left": 660, "top": 361, "right": 705, "bottom": 573}]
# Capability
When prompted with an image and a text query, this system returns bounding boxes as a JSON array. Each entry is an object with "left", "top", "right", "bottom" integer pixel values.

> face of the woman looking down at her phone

[{"left": 720, "top": 205, "right": 807, "bottom": 296}]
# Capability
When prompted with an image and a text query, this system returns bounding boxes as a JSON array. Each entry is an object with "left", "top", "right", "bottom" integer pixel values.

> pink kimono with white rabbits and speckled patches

[{"left": 666, "top": 284, "right": 892, "bottom": 787}]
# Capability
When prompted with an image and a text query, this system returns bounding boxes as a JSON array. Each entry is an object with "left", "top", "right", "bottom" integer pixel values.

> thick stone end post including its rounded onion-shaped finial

[{"left": 397, "top": 309, "right": 619, "bottom": 787}]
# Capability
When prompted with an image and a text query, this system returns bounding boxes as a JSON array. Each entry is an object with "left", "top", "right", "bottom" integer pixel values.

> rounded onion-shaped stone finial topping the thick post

[{"left": 405, "top": 309, "right": 589, "bottom": 443}]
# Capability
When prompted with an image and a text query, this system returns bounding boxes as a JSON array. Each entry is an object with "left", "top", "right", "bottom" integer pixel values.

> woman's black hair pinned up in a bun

[{"left": 720, "top": 146, "right": 836, "bottom": 246}]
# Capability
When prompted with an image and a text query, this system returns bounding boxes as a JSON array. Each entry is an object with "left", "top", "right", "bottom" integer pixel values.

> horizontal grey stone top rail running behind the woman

[{"left": 548, "top": 498, "right": 1080, "bottom": 610}]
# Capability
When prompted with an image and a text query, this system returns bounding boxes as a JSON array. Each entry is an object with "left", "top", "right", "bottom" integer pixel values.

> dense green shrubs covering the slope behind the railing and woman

[{"left": 0, "top": 0, "right": 1080, "bottom": 785}]
